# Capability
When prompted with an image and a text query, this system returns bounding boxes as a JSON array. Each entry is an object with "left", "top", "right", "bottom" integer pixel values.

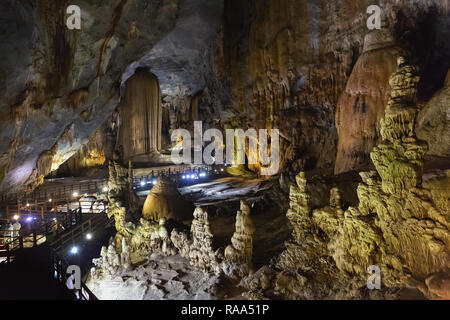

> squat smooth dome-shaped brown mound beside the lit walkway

[{"left": 142, "top": 178, "right": 194, "bottom": 221}]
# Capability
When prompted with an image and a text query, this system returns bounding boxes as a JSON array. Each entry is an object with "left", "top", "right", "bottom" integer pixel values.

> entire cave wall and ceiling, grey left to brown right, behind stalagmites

[{"left": 0, "top": 0, "right": 450, "bottom": 192}]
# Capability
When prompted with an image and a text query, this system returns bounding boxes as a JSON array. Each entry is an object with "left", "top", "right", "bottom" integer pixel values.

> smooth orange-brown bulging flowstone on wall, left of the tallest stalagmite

[{"left": 334, "top": 29, "right": 400, "bottom": 173}]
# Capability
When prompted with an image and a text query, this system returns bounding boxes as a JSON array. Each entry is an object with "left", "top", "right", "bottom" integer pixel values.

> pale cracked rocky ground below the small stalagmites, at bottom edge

[{"left": 87, "top": 254, "right": 242, "bottom": 300}]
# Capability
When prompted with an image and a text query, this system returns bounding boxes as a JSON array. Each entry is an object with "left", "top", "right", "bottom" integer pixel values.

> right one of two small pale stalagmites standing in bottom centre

[{"left": 225, "top": 201, "right": 255, "bottom": 275}]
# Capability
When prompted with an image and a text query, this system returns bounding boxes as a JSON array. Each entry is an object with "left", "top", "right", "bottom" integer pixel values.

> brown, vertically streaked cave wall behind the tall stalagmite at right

[{"left": 199, "top": 0, "right": 450, "bottom": 180}]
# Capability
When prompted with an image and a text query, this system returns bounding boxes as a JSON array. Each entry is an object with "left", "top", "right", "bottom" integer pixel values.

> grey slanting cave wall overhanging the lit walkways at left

[{"left": 0, "top": 0, "right": 222, "bottom": 193}]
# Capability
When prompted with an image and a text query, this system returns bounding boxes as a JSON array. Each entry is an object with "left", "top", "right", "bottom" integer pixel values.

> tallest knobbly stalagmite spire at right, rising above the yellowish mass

[{"left": 371, "top": 57, "right": 427, "bottom": 194}]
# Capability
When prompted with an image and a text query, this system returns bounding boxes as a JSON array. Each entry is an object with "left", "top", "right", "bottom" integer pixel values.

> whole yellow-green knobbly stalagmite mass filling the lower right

[{"left": 268, "top": 58, "right": 450, "bottom": 298}]
